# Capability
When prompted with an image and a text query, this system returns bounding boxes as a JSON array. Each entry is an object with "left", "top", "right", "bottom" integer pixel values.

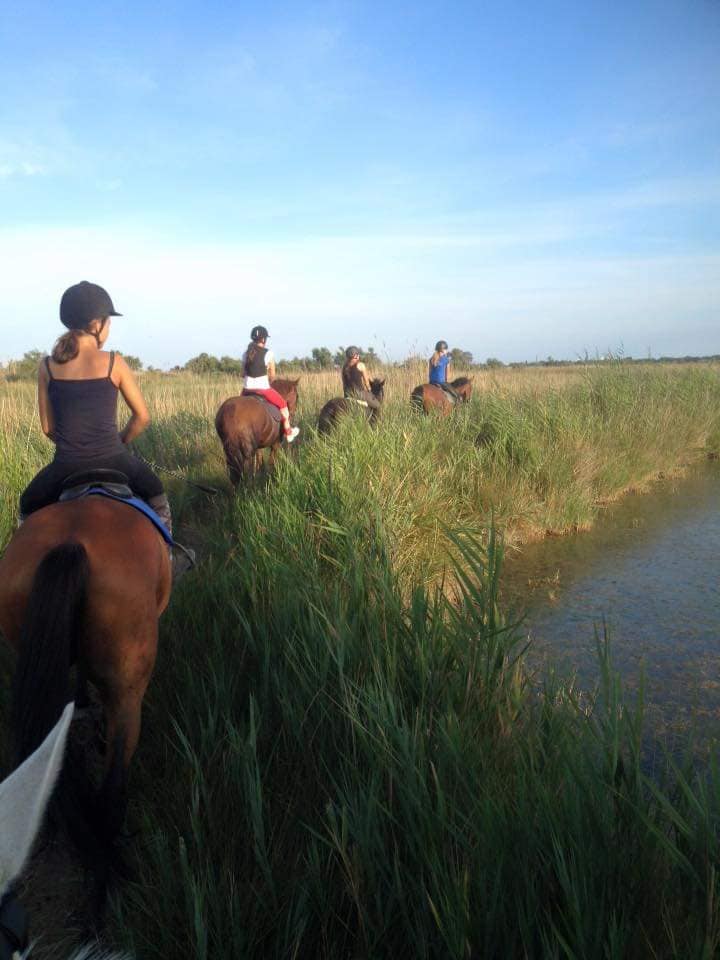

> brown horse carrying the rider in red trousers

[{"left": 215, "top": 377, "right": 300, "bottom": 486}]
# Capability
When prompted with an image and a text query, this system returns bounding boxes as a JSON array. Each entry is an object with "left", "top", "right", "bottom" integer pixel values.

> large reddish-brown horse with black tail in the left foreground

[{"left": 0, "top": 497, "right": 171, "bottom": 905}]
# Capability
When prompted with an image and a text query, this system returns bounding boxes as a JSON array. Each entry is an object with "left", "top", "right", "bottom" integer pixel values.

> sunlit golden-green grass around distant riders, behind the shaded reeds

[{"left": 0, "top": 364, "right": 720, "bottom": 583}]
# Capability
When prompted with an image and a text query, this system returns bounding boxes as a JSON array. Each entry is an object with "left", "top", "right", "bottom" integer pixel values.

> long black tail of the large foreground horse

[{"left": 12, "top": 542, "right": 89, "bottom": 764}]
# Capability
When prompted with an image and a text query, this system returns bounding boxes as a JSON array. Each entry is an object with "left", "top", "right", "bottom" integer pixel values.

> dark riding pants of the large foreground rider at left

[{"left": 20, "top": 451, "right": 164, "bottom": 517}]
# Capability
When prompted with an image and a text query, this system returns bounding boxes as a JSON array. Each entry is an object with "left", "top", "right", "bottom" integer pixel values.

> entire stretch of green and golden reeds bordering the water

[{"left": 0, "top": 365, "right": 720, "bottom": 960}]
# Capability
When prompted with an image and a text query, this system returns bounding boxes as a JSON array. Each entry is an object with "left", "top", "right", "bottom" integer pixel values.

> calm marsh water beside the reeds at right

[{"left": 502, "top": 461, "right": 720, "bottom": 740}]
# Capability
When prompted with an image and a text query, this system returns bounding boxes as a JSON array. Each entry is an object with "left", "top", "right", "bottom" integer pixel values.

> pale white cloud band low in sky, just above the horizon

[{"left": 0, "top": 228, "right": 720, "bottom": 366}]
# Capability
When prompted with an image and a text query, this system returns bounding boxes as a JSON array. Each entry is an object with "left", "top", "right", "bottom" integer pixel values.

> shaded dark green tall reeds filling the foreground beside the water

[{"left": 111, "top": 524, "right": 720, "bottom": 960}]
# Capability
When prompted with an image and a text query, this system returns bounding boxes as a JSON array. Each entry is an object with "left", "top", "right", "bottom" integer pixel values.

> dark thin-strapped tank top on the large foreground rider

[{"left": 45, "top": 352, "right": 126, "bottom": 463}]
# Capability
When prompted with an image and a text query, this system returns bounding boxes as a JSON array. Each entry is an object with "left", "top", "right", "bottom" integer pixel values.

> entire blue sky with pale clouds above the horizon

[{"left": 0, "top": 0, "right": 720, "bottom": 367}]
